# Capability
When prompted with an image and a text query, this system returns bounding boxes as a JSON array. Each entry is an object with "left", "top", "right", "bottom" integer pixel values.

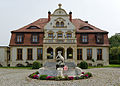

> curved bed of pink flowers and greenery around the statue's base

[{"left": 28, "top": 71, "right": 92, "bottom": 80}]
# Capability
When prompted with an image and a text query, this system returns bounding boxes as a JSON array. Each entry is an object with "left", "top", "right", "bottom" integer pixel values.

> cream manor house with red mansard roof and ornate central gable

[{"left": 0, "top": 4, "right": 109, "bottom": 66}]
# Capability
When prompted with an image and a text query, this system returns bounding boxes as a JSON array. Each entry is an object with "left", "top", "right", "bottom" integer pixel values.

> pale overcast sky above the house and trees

[{"left": 0, "top": 0, "right": 120, "bottom": 46}]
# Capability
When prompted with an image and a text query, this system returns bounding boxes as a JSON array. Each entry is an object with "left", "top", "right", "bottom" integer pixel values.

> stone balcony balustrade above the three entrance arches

[{"left": 43, "top": 39, "right": 77, "bottom": 44}]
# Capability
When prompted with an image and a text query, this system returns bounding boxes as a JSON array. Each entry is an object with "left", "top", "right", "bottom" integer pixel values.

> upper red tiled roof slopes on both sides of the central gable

[{"left": 12, "top": 18, "right": 107, "bottom": 32}]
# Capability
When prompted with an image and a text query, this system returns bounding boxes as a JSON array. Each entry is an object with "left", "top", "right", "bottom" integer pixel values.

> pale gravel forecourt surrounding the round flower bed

[{"left": 0, "top": 68, "right": 120, "bottom": 86}]
